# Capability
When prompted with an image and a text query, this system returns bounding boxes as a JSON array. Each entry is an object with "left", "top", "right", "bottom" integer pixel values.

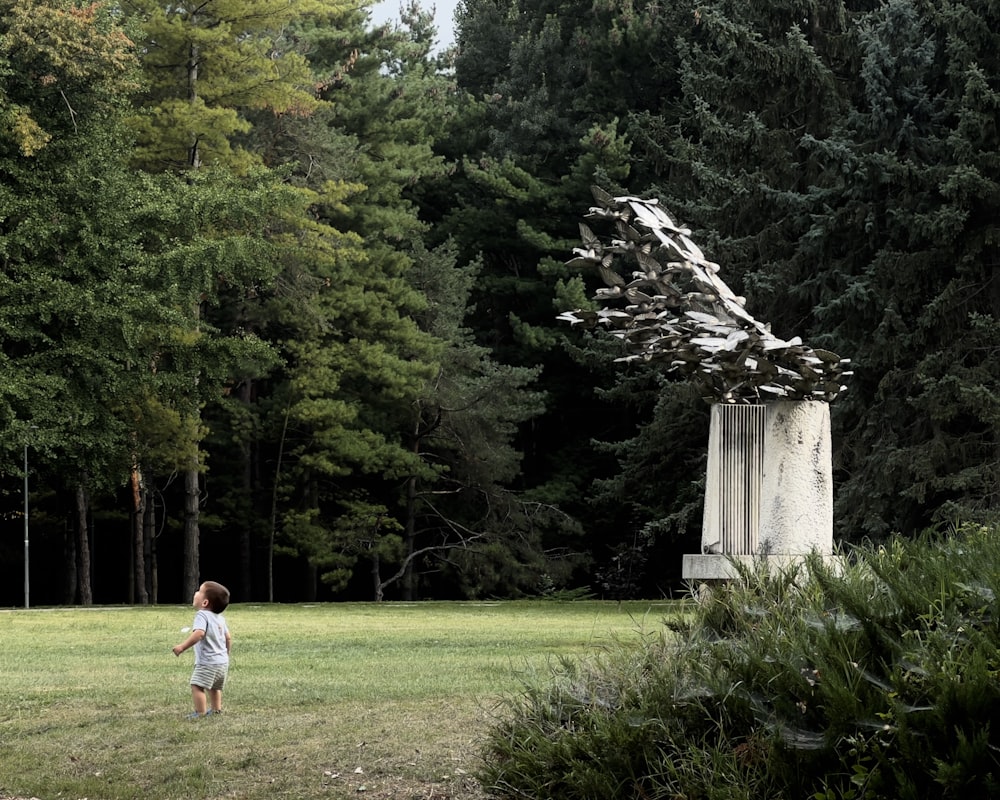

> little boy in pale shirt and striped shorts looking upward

[{"left": 174, "top": 581, "right": 233, "bottom": 719}]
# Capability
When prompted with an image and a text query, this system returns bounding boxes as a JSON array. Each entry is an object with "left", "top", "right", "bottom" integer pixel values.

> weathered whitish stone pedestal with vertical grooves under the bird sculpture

[{"left": 682, "top": 401, "right": 833, "bottom": 581}]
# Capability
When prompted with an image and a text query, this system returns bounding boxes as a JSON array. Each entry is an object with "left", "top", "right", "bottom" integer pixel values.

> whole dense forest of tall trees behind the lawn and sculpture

[{"left": 0, "top": 0, "right": 1000, "bottom": 605}]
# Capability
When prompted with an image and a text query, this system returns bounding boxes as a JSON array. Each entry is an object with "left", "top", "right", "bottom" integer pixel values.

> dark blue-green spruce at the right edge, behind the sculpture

[{"left": 794, "top": 0, "right": 1000, "bottom": 537}]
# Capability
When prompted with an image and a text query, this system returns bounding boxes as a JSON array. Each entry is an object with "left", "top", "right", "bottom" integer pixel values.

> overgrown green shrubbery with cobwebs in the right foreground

[{"left": 480, "top": 528, "right": 1000, "bottom": 800}]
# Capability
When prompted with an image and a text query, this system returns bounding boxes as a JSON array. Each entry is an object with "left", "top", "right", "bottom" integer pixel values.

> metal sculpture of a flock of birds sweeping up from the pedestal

[{"left": 558, "top": 186, "right": 851, "bottom": 404}]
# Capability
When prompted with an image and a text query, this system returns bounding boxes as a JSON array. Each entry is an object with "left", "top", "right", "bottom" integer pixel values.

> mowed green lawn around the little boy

[{"left": 0, "top": 601, "right": 680, "bottom": 800}]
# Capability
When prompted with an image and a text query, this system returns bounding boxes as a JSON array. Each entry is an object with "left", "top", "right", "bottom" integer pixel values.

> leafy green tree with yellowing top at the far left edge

[{"left": 0, "top": 0, "right": 174, "bottom": 604}]
